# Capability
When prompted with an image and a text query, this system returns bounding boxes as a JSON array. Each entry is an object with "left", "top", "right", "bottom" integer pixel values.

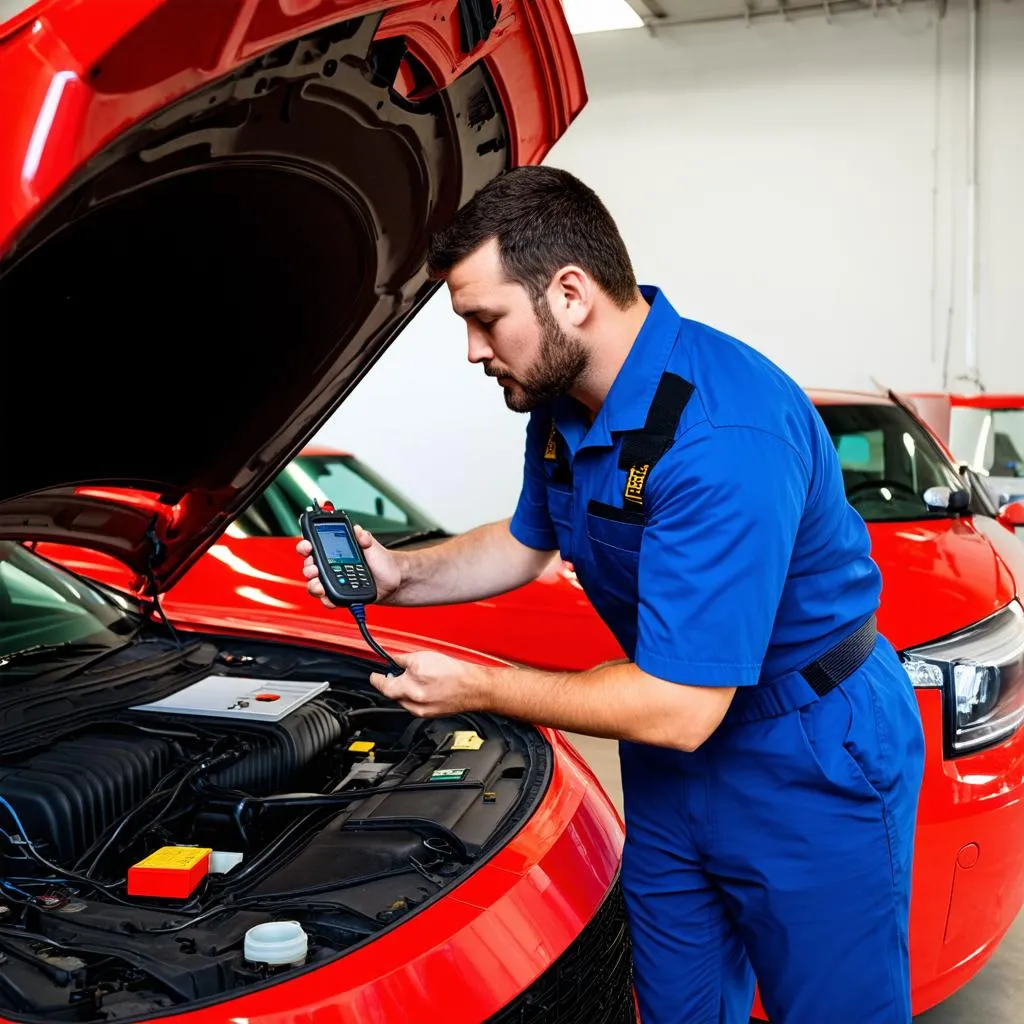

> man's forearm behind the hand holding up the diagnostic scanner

[{"left": 386, "top": 519, "right": 551, "bottom": 605}]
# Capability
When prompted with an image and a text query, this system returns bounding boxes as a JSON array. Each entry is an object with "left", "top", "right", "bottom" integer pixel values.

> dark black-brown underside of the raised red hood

[{"left": 0, "top": 4, "right": 574, "bottom": 591}]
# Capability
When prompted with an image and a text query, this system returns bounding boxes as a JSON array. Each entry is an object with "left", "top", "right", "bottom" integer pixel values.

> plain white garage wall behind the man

[{"left": 321, "top": 0, "right": 1024, "bottom": 529}]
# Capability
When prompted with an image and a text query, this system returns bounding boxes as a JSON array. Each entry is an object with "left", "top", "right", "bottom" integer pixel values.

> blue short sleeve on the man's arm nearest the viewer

[{"left": 634, "top": 424, "right": 809, "bottom": 686}]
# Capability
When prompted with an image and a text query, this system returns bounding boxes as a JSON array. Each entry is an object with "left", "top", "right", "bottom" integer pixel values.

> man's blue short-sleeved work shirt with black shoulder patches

[{"left": 511, "top": 288, "right": 882, "bottom": 686}]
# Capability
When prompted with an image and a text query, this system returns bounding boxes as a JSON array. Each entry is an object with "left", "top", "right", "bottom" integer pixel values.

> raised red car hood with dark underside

[{"left": 0, "top": 0, "right": 586, "bottom": 592}]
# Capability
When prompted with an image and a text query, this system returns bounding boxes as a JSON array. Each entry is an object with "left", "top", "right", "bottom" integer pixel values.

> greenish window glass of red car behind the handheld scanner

[{"left": 235, "top": 455, "right": 440, "bottom": 544}]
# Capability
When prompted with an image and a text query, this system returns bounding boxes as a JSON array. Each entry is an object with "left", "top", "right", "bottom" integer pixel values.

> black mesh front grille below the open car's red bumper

[{"left": 485, "top": 881, "right": 637, "bottom": 1024}]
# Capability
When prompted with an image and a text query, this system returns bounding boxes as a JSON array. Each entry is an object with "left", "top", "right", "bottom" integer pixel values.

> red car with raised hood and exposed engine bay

[{"left": 0, "top": 0, "right": 635, "bottom": 1024}]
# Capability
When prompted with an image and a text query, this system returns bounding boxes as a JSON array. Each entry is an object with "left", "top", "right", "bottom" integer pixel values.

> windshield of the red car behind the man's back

[{"left": 818, "top": 404, "right": 966, "bottom": 522}]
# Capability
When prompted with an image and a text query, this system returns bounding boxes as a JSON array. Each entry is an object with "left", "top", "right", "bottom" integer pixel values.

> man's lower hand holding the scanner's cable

[{"left": 370, "top": 651, "right": 485, "bottom": 718}]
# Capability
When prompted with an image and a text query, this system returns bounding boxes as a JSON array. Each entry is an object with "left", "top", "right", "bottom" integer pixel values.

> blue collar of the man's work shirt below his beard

[{"left": 555, "top": 285, "right": 682, "bottom": 452}]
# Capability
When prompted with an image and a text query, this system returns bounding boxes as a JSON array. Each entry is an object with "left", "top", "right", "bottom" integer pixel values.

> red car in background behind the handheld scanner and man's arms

[{"left": 36, "top": 444, "right": 625, "bottom": 671}]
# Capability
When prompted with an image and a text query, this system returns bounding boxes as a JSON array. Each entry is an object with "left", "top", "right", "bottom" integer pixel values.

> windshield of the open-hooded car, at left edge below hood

[{"left": 0, "top": 541, "right": 138, "bottom": 667}]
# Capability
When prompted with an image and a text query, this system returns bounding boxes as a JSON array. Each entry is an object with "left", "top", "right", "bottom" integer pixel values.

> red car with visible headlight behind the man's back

[{"left": 794, "top": 391, "right": 1024, "bottom": 1013}]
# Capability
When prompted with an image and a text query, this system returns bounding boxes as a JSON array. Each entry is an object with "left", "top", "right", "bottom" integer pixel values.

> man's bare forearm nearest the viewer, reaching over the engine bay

[{"left": 476, "top": 663, "right": 735, "bottom": 751}]
